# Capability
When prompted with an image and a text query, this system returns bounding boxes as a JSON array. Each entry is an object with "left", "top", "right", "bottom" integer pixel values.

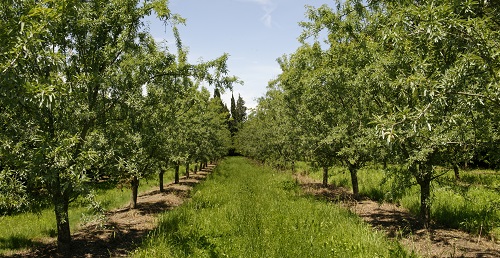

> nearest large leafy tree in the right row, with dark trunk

[{"left": 370, "top": 1, "right": 500, "bottom": 227}]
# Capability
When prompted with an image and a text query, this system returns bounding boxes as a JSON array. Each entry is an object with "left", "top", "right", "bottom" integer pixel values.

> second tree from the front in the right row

[{"left": 292, "top": 1, "right": 379, "bottom": 196}]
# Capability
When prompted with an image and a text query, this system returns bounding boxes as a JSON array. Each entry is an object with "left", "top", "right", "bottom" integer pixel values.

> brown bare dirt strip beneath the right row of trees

[{"left": 296, "top": 175, "right": 500, "bottom": 257}]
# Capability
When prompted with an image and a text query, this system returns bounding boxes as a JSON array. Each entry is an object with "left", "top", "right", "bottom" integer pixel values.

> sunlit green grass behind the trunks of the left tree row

[{"left": 0, "top": 169, "right": 177, "bottom": 255}]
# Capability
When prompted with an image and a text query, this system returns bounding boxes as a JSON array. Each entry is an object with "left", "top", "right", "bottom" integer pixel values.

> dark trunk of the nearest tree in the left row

[{"left": 53, "top": 187, "right": 71, "bottom": 255}]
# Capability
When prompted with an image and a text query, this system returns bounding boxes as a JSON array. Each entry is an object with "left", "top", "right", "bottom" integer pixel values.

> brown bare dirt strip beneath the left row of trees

[{"left": 7, "top": 165, "right": 215, "bottom": 257}]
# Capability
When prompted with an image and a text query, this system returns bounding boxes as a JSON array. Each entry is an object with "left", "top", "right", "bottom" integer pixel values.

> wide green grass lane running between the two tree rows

[{"left": 133, "top": 157, "right": 409, "bottom": 257}]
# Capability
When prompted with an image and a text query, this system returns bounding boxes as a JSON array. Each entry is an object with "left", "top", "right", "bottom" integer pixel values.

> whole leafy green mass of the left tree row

[{"left": 0, "top": 0, "right": 236, "bottom": 251}]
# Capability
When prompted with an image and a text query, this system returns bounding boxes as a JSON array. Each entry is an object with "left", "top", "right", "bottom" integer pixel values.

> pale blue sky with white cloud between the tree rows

[{"left": 145, "top": 0, "right": 334, "bottom": 107}]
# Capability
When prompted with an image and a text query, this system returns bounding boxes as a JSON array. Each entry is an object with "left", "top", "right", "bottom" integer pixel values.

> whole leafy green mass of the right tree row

[{"left": 240, "top": 0, "right": 500, "bottom": 227}]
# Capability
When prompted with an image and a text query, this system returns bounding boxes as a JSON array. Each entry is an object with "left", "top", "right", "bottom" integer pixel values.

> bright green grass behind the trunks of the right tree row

[{"left": 297, "top": 162, "right": 500, "bottom": 239}]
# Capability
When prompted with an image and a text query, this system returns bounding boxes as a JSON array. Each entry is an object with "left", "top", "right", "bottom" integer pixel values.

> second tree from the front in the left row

[{"left": 106, "top": 37, "right": 159, "bottom": 209}]
